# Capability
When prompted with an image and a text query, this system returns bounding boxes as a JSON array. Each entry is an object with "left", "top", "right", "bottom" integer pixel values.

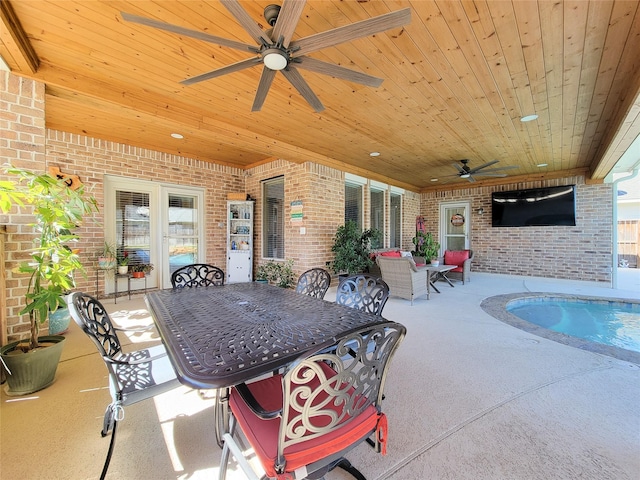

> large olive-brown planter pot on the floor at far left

[{"left": 0, "top": 335, "right": 65, "bottom": 396}]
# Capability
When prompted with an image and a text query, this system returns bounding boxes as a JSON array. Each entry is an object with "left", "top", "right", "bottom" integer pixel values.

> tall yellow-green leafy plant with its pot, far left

[{"left": 0, "top": 165, "right": 98, "bottom": 395}]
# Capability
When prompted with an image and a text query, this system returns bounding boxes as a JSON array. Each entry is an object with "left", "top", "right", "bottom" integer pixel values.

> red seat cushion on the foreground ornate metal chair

[{"left": 229, "top": 362, "right": 382, "bottom": 478}]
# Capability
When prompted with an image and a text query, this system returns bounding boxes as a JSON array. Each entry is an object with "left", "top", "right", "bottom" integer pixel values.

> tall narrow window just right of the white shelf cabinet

[{"left": 262, "top": 177, "right": 284, "bottom": 259}]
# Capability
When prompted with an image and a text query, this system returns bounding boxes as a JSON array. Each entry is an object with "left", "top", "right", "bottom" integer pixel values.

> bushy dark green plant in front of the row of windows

[{"left": 331, "top": 220, "right": 382, "bottom": 275}]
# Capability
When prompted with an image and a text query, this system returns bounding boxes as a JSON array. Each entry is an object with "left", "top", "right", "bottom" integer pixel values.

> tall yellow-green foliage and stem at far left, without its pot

[{"left": 0, "top": 165, "right": 98, "bottom": 349}]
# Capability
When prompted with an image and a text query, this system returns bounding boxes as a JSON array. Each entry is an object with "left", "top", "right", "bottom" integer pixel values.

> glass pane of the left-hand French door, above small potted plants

[{"left": 116, "top": 190, "right": 151, "bottom": 265}]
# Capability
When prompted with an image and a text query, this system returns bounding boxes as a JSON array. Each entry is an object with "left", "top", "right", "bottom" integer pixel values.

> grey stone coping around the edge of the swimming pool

[{"left": 480, "top": 292, "right": 640, "bottom": 365}]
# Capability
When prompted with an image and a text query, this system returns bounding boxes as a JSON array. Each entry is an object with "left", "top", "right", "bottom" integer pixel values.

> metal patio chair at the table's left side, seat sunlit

[{"left": 68, "top": 292, "right": 181, "bottom": 480}]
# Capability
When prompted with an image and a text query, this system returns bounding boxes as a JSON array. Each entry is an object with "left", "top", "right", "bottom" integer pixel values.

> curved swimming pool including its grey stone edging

[{"left": 481, "top": 293, "right": 640, "bottom": 364}]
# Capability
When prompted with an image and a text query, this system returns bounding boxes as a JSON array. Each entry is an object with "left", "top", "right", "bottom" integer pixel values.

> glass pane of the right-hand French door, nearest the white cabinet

[{"left": 167, "top": 194, "right": 198, "bottom": 274}]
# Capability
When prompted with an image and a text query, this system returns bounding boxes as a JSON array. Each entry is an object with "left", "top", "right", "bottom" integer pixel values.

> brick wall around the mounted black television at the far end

[{"left": 421, "top": 177, "right": 613, "bottom": 283}]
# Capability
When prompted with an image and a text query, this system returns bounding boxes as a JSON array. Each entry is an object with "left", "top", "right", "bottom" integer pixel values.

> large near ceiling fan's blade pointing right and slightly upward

[{"left": 290, "top": 8, "right": 411, "bottom": 57}]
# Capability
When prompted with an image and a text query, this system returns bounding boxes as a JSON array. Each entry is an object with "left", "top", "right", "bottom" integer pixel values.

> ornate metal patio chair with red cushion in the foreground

[{"left": 219, "top": 321, "right": 406, "bottom": 480}]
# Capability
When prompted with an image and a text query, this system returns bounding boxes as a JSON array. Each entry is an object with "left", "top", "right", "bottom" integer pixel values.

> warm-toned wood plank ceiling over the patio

[{"left": 0, "top": 0, "right": 640, "bottom": 191}]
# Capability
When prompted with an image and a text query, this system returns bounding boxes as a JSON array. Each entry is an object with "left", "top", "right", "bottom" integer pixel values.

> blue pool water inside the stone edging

[{"left": 507, "top": 297, "right": 640, "bottom": 352}]
